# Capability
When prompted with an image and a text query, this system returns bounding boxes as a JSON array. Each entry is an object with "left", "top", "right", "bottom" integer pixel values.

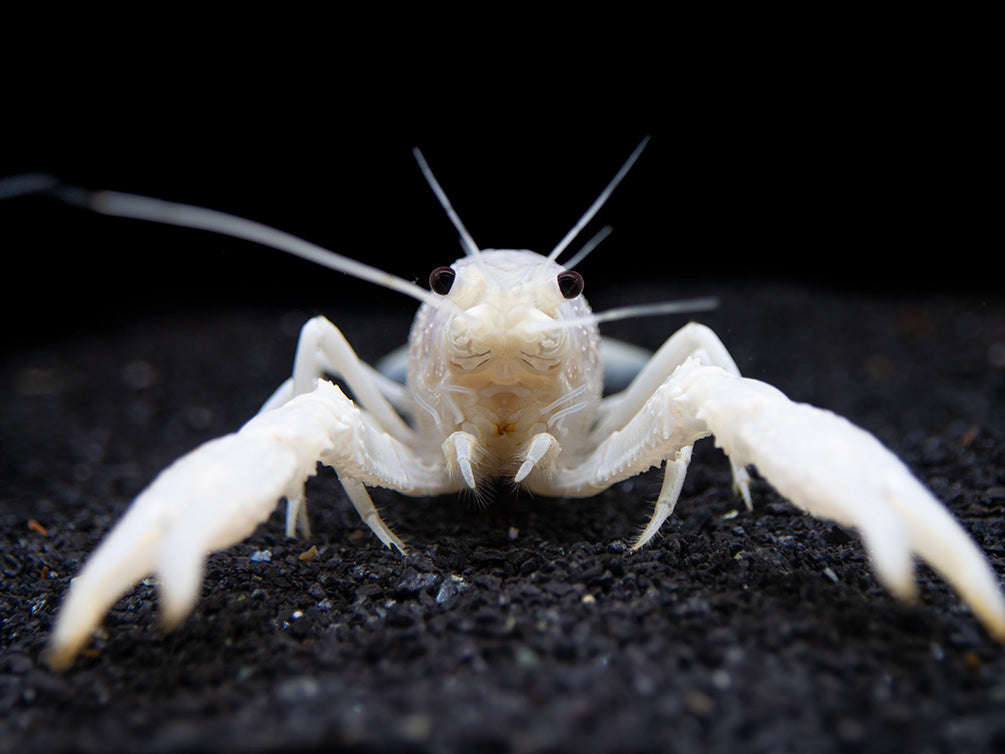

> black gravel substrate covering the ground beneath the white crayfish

[{"left": 0, "top": 284, "right": 1005, "bottom": 754}]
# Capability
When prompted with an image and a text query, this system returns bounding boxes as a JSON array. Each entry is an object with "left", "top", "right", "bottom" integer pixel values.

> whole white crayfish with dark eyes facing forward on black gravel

[{"left": 7, "top": 142, "right": 1005, "bottom": 668}]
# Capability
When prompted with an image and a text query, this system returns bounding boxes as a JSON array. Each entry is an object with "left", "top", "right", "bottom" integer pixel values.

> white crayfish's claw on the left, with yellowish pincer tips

[{"left": 48, "top": 382, "right": 352, "bottom": 668}]
